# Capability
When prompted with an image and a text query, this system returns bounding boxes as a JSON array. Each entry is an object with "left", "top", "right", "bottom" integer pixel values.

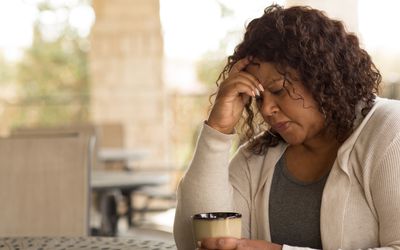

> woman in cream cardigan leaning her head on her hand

[{"left": 174, "top": 5, "right": 400, "bottom": 250}]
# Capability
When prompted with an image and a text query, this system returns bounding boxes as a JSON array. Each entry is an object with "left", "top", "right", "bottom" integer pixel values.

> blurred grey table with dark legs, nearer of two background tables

[{"left": 91, "top": 170, "right": 169, "bottom": 236}]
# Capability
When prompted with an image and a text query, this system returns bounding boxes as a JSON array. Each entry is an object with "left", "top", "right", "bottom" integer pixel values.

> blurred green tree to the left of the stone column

[{"left": 13, "top": 3, "right": 90, "bottom": 126}]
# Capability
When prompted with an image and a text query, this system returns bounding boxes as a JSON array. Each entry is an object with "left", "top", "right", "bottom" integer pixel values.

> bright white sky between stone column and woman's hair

[{"left": 160, "top": 0, "right": 284, "bottom": 58}]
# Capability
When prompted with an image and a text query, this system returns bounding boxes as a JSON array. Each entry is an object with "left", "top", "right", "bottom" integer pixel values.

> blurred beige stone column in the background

[{"left": 90, "top": 0, "right": 168, "bottom": 168}]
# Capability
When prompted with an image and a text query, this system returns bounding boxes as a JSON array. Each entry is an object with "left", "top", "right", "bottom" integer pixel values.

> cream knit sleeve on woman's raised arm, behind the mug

[{"left": 174, "top": 124, "right": 253, "bottom": 250}]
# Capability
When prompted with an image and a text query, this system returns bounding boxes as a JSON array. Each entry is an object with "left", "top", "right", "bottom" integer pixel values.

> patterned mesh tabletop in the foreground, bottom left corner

[{"left": 0, "top": 237, "right": 176, "bottom": 250}]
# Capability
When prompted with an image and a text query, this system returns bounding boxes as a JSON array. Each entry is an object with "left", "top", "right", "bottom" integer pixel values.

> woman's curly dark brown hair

[{"left": 217, "top": 4, "right": 382, "bottom": 155}]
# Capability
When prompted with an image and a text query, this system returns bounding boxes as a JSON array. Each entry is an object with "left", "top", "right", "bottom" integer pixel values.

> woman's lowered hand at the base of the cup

[{"left": 200, "top": 237, "right": 282, "bottom": 250}]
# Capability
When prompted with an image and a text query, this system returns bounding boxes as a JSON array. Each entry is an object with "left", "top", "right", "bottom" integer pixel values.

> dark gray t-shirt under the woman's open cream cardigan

[{"left": 269, "top": 157, "right": 328, "bottom": 249}]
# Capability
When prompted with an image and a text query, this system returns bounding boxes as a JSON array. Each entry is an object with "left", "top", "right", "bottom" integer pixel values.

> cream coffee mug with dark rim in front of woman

[{"left": 192, "top": 212, "right": 242, "bottom": 242}]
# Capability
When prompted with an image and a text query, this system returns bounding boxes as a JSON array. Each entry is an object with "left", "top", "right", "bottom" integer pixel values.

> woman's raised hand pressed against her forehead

[{"left": 206, "top": 57, "right": 264, "bottom": 134}]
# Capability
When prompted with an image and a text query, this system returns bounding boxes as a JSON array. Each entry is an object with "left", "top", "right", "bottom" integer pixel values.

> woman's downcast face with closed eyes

[{"left": 246, "top": 60, "right": 325, "bottom": 145}]
